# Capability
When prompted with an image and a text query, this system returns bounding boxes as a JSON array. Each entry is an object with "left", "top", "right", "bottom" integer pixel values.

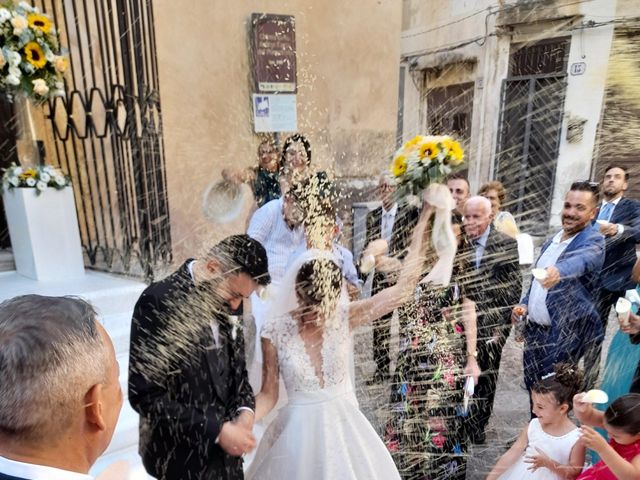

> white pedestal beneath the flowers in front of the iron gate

[{"left": 2, "top": 187, "right": 84, "bottom": 281}]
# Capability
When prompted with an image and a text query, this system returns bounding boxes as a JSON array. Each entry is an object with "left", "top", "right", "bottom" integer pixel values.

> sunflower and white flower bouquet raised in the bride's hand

[{"left": 391, "top": 135, "right": 464, "bottom": 197}]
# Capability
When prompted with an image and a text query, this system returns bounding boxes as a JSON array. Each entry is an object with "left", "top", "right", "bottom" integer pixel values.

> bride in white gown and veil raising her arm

[{"left": 247, "top": 201, "right": 433, "bottom": 480}]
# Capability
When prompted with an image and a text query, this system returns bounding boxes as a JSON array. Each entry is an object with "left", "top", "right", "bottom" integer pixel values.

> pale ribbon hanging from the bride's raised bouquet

[{"left": 422, "top": 183, "right": 458, "bottom": 286}]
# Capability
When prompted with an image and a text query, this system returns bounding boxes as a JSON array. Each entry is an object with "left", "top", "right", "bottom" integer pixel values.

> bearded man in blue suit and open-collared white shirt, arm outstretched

[{"left": 512, "top": 182, "right": 604, "bottom": 412}]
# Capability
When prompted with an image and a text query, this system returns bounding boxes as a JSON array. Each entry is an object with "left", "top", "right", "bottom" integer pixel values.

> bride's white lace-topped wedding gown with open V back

[{"left": 246, "top": 303, "right": 400, "bottom": 480}]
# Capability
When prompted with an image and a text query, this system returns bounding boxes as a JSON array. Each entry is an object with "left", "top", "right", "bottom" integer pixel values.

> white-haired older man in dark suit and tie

[{"left": 463, "top": 196, "right": 522, "bottom": 444}]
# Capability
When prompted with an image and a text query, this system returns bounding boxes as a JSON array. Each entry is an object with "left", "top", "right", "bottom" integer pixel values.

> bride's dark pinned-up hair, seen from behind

[{"left": 296, "top": 258, "right": 342, "bottom": 305}]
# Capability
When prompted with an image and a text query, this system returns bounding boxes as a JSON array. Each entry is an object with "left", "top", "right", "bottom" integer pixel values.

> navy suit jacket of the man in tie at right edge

[{"left": 601, "top": 197, "right": 640, "bottom": 292}]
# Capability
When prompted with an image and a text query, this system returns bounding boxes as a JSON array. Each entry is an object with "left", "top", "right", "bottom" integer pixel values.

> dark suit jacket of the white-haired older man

[{"left": 462, "top": 227, "right": 522, "bottom": 340}]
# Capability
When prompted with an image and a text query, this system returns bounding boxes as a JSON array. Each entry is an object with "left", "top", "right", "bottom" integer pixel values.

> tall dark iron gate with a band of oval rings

[{"left": 34, "top": 0, "right": 171, "bottom": 278}]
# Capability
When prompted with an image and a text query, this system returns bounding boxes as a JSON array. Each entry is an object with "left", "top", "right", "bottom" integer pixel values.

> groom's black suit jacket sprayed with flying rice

[{"left": 129, "top": 262, "right": 255, "bottom": 480}]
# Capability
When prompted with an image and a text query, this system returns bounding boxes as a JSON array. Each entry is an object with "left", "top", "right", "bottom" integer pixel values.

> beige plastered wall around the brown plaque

[{"left": 154, "top": 0, "right": 401, "bottom": 262}]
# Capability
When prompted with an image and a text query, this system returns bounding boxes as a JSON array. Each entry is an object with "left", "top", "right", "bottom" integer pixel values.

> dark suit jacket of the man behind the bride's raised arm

[{"left": 365, "top": 203, "right": 420, "bottom": 288}]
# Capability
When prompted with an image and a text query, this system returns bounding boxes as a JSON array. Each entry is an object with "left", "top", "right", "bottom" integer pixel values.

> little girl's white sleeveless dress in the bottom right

[{"left": 498, "top": 418, "right": 580, "bottom": 480}]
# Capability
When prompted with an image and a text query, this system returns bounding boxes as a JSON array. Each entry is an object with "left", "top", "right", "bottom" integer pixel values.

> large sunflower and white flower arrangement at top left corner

[{"left": 0, "top": 2, "right": 67, "bottom": 102}]
